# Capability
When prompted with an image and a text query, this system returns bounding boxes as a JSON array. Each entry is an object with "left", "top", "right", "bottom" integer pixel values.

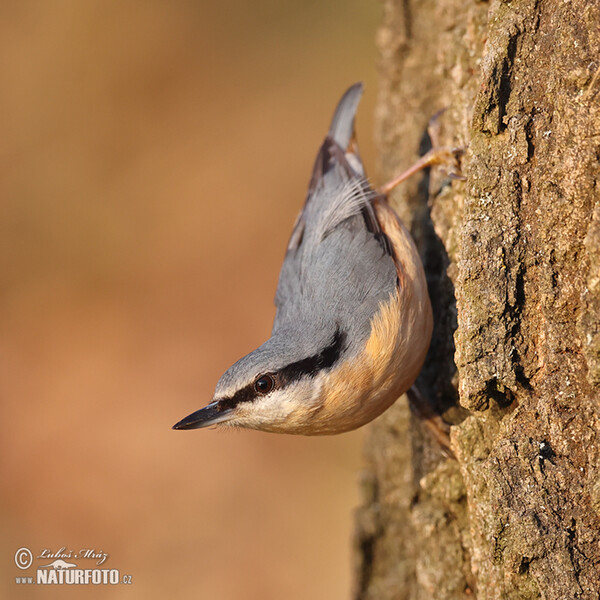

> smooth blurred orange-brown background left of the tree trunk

[{"left": 0, "top": 0, "right": 380, "bottom": 600}]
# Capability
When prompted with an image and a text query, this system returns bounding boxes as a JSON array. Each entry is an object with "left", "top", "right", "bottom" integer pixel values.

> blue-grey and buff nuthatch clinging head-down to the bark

[{"left": 174, "top": 84, "right": 433, "bottom": 435}]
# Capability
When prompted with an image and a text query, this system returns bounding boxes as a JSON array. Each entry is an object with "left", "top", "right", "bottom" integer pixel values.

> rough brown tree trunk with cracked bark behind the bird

[{"left": 355, "top": 0, "right": 600, "bottom": 600}]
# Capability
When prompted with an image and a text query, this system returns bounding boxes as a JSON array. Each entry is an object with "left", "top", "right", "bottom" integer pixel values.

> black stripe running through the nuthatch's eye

[{"left": 217, "top": 329, "right": 347, "bottom": 410}]
